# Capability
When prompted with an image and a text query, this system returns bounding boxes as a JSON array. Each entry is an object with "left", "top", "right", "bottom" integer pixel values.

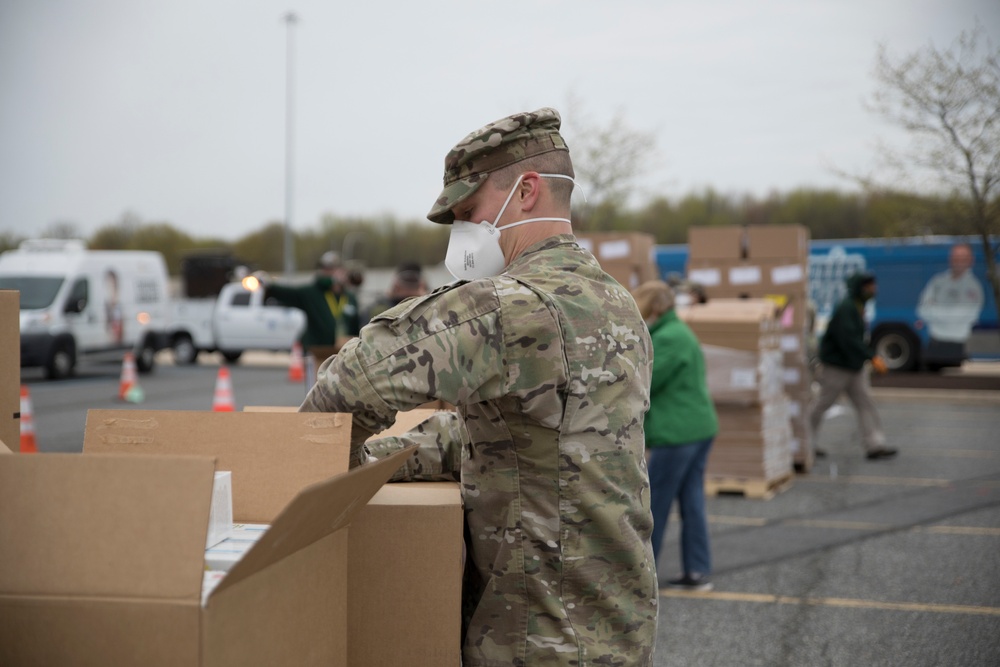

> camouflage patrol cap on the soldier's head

[{"left": 427, "top": 107, "right": 569, "bottom": 225}]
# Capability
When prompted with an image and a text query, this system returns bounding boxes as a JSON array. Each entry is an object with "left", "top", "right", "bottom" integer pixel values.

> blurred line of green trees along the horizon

[{"left": 0, "top": 189, "right": 973, "bottom": 275}]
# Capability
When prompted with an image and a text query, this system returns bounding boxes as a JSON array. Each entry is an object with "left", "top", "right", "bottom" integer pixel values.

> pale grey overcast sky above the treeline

[{"left": 0, "top": 0, "right": 1000, "bottom": 240}]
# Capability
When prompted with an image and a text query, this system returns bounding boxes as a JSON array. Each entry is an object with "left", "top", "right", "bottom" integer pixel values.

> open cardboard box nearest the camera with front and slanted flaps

[{"left": 0, "top": 450, "right": 413, "bottom": 667}]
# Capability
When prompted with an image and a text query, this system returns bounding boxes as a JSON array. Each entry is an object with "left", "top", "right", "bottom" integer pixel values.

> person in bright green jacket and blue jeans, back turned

[{"left": 632, "top": 280, "right": 719, "bottom": 590}]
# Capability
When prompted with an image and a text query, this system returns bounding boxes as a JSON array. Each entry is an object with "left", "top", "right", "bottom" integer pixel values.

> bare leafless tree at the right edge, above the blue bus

[{"left": 871, "top": 23, "right": 1000, "bottom": 326}]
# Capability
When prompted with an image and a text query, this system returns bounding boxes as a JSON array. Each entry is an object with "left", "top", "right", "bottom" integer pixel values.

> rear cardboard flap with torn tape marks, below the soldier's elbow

[{"left": 83, "top": 410, "right": 351, "bottom": 523}]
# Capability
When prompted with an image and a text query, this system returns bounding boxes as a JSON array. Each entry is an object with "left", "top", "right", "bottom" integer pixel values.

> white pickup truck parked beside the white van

[{"left": 170, "top": 283, "right": 306, "bottom": 364}]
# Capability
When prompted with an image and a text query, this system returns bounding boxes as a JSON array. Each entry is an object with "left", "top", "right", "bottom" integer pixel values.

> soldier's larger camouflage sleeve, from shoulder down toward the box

[{"left": 299, "top": 280, "right": 506, "bottom": 465}]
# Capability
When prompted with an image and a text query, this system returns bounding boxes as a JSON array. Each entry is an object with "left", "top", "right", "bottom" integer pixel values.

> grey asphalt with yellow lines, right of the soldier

[{"left": 655, "top": 388, "right": 1000, "bottom": 667}]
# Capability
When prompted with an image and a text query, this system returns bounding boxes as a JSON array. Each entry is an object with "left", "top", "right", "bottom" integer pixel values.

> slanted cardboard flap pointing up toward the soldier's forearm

[{"left": 209, "top": 446, "right": 417, "bottom": 599}]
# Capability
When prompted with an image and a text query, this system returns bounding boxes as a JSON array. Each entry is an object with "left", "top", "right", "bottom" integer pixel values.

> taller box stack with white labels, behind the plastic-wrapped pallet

[{"left": 687, "top": 225, "right": 813, "bottom": 486}]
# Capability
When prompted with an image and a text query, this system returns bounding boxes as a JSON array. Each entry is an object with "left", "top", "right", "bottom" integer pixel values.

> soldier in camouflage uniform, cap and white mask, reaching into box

[{"left": 300, "top": 109, "right": 657, "bottom": 667}]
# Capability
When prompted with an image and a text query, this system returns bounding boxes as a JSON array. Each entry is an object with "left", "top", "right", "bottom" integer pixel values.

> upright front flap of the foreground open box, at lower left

[{"left": 0, "top": 454, "right": 215, "bottom": 600}]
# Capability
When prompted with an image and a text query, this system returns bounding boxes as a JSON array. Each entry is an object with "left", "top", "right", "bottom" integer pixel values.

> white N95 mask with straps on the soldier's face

[{"left": 444, "top": 174, "right": 575, "bottom": 280}]
